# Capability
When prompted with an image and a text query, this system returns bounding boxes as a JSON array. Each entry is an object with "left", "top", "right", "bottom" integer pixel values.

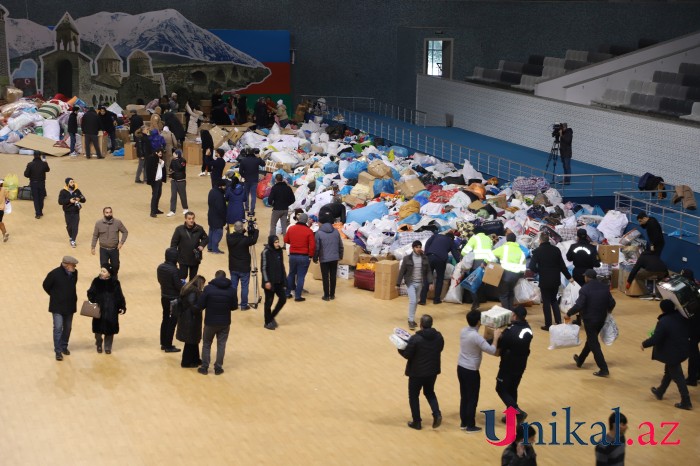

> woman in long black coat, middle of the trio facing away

[{"left": 175, "top": 275, "right": 206, "bottom": 368}]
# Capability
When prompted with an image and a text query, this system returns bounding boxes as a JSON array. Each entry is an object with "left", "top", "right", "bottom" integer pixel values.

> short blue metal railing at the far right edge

[{"left": 615, "top": 191, "right": 700, "bottom": 245}]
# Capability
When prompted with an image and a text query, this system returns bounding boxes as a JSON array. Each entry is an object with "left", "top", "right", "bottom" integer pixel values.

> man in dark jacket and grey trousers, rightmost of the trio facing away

[{"left": 197, "top": 270, "right": 237, "bottom": 375}]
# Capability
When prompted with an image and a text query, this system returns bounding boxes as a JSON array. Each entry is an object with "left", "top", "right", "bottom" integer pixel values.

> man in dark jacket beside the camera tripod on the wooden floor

[{"left": 226, "top": 217, "right": 260, "bottom": 311}]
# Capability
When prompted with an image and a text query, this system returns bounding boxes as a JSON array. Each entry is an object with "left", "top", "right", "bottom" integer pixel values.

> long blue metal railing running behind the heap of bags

[{"left": 329, "top": 107, "right": 636, "bottom": 197}]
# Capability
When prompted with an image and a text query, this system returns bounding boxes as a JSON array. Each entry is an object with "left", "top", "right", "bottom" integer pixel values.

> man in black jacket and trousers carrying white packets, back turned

[{"left": 399, "top": 314, "right": 445, "bottom": 430}]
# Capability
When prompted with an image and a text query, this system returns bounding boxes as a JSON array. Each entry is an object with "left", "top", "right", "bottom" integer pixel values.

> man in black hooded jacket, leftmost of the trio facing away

[{"left": 156, "top": 248, "right": 183, "bottom": 353}]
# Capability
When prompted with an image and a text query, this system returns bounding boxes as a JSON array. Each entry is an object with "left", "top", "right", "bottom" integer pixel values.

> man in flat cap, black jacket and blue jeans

[{"left": 42, "top": 256, "right": 78, "bottom": 361}]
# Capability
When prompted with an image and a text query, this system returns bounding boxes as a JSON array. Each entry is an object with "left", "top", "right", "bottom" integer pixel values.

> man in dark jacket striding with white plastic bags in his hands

[{"left": 566, "top": 269, "right": 616, "bottom": 377}]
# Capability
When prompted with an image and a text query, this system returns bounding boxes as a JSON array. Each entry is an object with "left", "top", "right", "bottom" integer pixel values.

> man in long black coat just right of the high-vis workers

[{"left": 529, "top": 233, "right": 573, "bottom": 331}]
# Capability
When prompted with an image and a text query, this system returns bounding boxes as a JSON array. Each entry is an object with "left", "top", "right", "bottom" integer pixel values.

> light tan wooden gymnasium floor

[{"left": 0, "top": 151, "right": 700, "bottom": 465}]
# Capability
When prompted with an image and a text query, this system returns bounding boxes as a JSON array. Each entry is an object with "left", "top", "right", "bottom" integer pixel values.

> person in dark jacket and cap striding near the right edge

[{"left": 642, "top": 299, "right": 693, "bottom": 410}]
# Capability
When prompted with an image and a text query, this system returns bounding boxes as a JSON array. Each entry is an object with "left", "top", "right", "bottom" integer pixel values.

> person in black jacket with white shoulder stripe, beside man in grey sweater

[{"left": 496, "top": 306, "right": 533, "bottom": 423}]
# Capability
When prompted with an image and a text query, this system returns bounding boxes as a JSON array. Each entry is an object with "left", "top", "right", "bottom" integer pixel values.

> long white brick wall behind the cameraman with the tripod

[{"left": 416, "top": 75, "right": 700, "bottom": 191}]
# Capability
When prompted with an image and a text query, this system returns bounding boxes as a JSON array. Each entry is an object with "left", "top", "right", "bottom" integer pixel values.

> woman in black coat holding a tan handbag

[{"left": 87, "top": 264, "right": 126, "bottom": 354}]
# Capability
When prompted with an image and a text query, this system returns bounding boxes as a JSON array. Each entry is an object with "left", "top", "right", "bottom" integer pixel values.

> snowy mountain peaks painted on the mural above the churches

[{"left": 6, "top": 9, "right": 264, "bottom": 67}]
